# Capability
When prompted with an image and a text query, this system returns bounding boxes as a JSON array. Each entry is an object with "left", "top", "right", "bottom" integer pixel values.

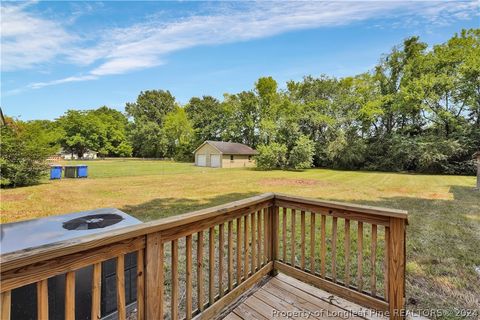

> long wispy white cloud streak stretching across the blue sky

[{"left": 2, "top": 1, "right": 479, "bottom": 88}]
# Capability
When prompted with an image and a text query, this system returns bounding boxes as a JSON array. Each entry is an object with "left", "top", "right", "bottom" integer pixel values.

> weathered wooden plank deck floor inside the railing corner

[{"left": 219, "top": 273, "right": 387, "bottom": 320}]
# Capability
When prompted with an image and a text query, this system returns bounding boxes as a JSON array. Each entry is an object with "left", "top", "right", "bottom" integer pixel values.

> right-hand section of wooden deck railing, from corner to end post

[{"left": 272, "top": 194, "right": 408, "bottom": 319}]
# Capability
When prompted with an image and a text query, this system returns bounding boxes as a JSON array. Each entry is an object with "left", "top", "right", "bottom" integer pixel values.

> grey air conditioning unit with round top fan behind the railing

[{"left": 0, "top": 208, "right": 141, "bottom": 320}]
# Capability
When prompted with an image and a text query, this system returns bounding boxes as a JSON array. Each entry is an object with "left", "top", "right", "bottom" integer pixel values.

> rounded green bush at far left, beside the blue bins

[{"left": 0, "top": 119, "right": 52, "bottom": 187}]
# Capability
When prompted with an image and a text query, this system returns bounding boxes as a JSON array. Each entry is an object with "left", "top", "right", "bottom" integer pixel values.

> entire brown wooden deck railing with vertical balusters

[{"left": 0, "top": 194, "right": 407, "bottom": 320}]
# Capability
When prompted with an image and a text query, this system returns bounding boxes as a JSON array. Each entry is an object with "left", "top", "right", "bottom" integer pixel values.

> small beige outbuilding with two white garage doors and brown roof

[{"left": 193, "top": 140, "right": 257, "bottom": 168}]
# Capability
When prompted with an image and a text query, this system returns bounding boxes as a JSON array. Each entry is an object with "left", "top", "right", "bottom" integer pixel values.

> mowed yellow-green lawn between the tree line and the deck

[{"left": 1, "top": 160, "right": 480, "bottom": 319}]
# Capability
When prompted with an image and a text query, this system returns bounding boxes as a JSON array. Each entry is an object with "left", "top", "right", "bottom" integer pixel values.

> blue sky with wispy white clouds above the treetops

[{"left": 0, "top": 1, "right": 480, "bottom": 120}]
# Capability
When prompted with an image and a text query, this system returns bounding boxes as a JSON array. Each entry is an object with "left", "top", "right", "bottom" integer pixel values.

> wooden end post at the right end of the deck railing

[{"left": 388, "top": 217, "right": 406, "bottom": 320}]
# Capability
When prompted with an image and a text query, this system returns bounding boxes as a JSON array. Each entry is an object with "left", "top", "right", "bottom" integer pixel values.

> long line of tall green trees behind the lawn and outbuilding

[{"left": 2, "top": 29, "right": 480, "bottom": 186}]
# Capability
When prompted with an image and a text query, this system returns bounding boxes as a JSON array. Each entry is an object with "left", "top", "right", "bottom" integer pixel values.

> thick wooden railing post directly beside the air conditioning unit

[{"left": 145, "top": 232, "right": 164, "bottom": 320}]
